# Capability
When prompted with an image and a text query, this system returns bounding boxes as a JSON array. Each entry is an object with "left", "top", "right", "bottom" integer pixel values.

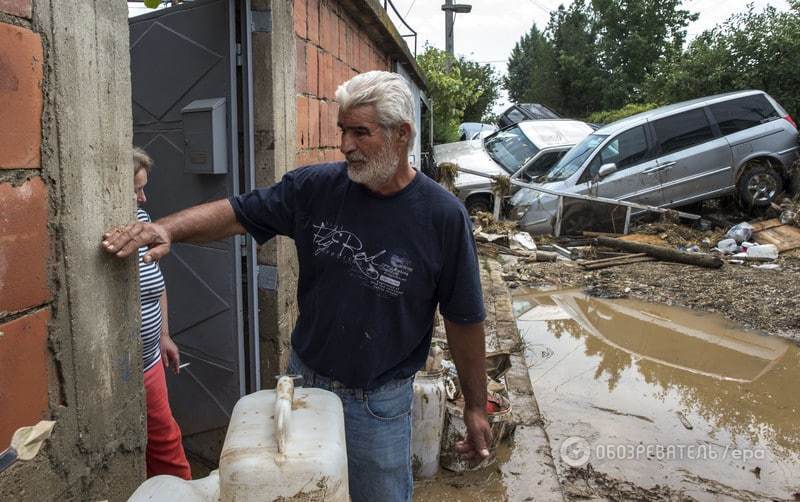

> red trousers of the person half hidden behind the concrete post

[{"left": 144, "top": 361, "right": 192, "bottom": 480}]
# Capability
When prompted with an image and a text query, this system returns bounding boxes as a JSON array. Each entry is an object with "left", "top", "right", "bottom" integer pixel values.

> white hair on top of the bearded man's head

[{"left": 336, "top": 71, "right": 417, "bottom": 151}]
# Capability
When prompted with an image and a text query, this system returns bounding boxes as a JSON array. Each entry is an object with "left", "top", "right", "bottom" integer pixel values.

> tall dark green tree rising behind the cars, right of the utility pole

[{"left": 503, "top": 0, "right": 696, "bottom": 117}]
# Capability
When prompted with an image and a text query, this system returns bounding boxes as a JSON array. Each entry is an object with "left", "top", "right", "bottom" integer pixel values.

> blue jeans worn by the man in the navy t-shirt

[{"left": 288, "top": 351, "right": 414, "bottom": 502}]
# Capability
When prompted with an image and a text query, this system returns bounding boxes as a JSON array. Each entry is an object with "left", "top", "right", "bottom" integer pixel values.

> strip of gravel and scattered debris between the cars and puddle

[{"left": 475, "top": 212, "right": 800, "bottom": 343}]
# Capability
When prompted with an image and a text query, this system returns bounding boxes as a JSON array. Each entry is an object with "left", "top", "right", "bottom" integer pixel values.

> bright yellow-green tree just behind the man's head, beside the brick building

[{"left": 417, "top": 46, "right": 482, "bottom": 143}]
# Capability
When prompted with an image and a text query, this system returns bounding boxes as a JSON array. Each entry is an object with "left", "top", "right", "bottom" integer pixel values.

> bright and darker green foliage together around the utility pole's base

[{"left": 417, "top": 46, "right": 500, "bottom": 143}]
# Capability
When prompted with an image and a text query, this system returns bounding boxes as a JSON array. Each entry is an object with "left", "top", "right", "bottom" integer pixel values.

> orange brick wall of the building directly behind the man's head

[{"left": 294, "top": 0, "right": 390, "bottom": 166}]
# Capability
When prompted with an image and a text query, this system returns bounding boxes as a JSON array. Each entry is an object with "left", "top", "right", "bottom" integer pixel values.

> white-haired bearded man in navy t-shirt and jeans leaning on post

[{"left": 102, "top": 71, "right": 491, "bottom": 502}]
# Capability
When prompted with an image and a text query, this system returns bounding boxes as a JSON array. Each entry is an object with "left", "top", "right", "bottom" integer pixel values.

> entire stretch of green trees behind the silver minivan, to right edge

[{"left": 503, "top": 0, "right": 800, "bottom": 123}]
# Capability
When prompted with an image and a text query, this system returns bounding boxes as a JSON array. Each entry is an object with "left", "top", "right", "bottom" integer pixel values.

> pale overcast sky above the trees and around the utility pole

[{"left": 380, "top": 0, "right": 789, "bottom": 113}]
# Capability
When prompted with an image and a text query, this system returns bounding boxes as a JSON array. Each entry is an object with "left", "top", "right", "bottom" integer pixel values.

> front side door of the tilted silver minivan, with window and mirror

[{"left": 579, "top": 125, "right": 660, "bottom": 204}]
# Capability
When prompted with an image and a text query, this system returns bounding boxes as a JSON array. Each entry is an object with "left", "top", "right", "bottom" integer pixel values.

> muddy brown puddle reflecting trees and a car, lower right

[{"left": 514, "top": 290, "right": 800, "bottom": 500}]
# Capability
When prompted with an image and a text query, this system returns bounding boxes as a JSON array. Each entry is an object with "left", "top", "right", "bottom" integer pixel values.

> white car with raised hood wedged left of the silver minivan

[{"left": 433, "top": 119, "right": 592, "bottom": 213}]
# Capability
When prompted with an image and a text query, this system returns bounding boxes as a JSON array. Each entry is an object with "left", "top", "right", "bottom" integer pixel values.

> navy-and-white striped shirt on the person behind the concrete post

[{"left": 136, "top": 209, "right": 165, "bottom": 371}]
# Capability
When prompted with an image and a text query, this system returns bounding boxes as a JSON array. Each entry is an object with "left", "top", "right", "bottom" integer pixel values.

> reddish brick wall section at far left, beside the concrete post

[{"left": 0, "top": 0, "right": 51, "bottom": 450}]
